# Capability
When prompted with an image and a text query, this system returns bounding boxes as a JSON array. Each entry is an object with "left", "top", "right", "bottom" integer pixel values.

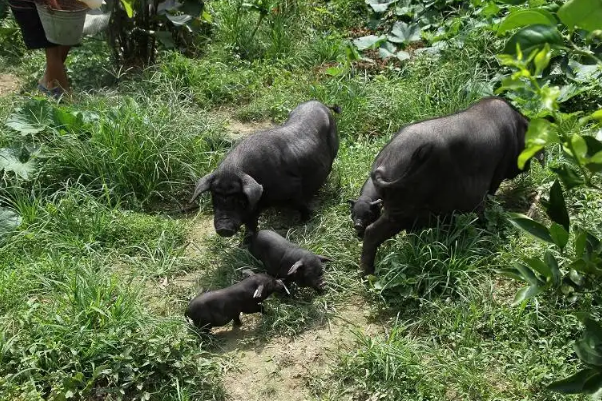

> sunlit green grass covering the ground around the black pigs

[{"left": 0, "top": 0, "right": 601, "bottom": 400}]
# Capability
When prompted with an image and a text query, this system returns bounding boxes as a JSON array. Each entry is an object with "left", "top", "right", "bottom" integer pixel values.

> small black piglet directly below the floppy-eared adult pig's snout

[{"left": 249, "top": 230, "right": 330, "bottom": 292}]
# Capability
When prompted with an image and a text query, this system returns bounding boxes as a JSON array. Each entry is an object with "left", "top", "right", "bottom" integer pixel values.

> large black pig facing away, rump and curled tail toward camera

[{"left": 360, "top": 97, "right": 529, "bottom": 274}]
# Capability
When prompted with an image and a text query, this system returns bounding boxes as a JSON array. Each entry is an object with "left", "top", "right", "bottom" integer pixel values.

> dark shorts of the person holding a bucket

[{"left": 8, "top": 0, "right": 58, "bottom": 49}]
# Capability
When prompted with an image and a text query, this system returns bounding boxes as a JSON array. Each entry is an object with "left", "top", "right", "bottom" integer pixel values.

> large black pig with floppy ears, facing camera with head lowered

[{"left": 190, "top": 101, "right": 339, "bottom": 237}]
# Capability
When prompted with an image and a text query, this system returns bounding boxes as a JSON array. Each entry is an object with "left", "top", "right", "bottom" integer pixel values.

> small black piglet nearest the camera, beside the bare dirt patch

[{"left": 185, "top": 274, "right": 284, "bottom": 331}]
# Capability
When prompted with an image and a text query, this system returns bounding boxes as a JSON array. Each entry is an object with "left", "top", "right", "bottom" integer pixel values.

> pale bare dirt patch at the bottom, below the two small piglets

[{"left": 216, "top": 299, "right": 383, "bottom": 401}]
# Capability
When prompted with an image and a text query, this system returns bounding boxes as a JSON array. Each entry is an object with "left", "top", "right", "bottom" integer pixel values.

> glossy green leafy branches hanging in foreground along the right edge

[{"left": 497, "top": 0, "right": 602, "bottom": 394}]
